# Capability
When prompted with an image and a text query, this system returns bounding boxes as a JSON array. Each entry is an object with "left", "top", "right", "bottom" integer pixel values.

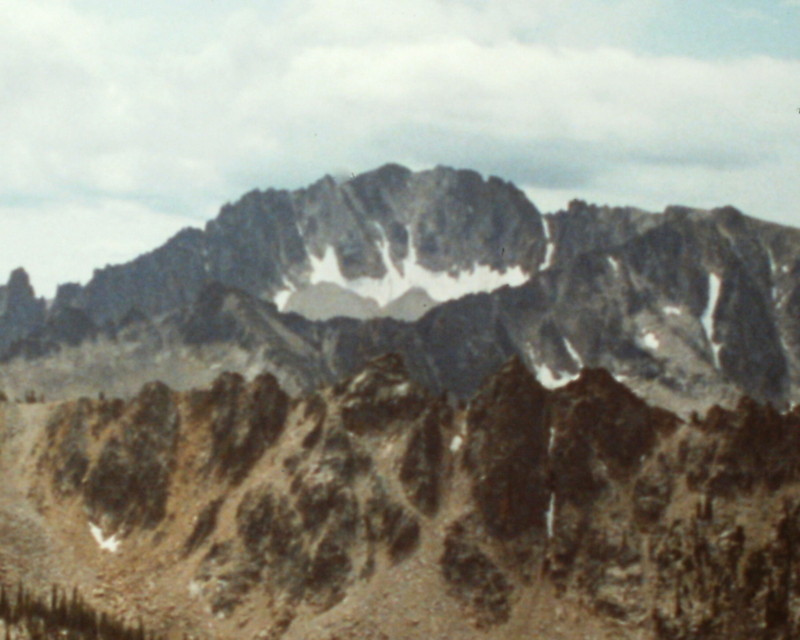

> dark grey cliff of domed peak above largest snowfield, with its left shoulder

[{"left": 48, "top": 165, "right": 544, "bottom": 324}]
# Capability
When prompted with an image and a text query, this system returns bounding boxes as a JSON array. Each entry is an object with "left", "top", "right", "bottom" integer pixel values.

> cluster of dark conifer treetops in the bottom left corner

[{"left": 0, "top": 583, "right": 163, "bottom": 640}]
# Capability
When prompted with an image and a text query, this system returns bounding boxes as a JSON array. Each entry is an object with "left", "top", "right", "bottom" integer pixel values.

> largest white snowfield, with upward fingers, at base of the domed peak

[{"left": 304, "top": 225, "right": 528, "bottom": 307}]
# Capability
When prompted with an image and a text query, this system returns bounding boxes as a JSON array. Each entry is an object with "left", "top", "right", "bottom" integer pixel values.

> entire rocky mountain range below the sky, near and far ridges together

[{"left": 0, "top": 165, "right": 800, "bottom": 640}]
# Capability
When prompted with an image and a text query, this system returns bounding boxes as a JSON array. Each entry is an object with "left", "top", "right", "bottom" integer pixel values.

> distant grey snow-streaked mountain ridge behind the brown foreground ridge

[{"left": 0, "top": 165, "right": 800, "bottom": 411}]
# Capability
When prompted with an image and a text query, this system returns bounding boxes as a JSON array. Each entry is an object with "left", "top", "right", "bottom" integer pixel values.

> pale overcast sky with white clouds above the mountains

[{"left": 0, "top": 0, "right": 800, "bottom": 296}]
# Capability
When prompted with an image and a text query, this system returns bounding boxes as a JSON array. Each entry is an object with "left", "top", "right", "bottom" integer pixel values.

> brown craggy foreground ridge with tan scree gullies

[{"left": 0, "top": 355, "right": 800, "bottom": 640}]
